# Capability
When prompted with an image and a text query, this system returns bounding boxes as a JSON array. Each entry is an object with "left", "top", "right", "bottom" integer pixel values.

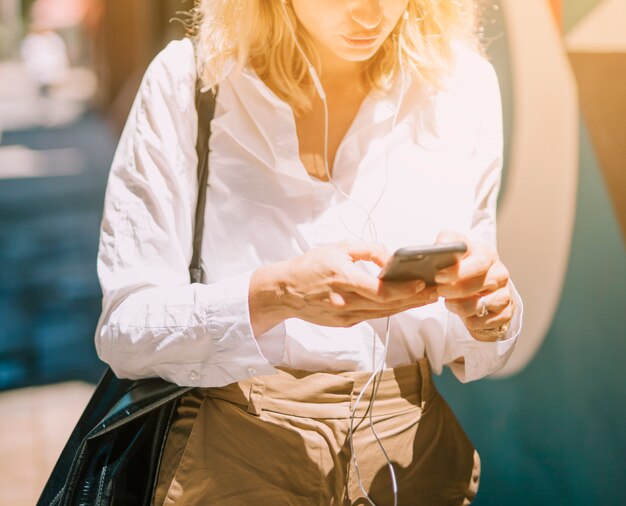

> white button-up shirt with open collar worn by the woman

[{"left": 96, "top": 40, "right": 522, "bottom": 387}]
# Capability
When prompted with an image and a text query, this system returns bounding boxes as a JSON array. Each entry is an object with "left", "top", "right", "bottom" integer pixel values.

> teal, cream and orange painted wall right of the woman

[{"left": 437, "top": 0, "right": 626, "bottom": 506}]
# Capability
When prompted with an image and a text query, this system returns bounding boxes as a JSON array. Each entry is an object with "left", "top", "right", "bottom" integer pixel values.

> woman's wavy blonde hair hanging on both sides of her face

[{"left": 191, "top": 0, "right": 479, "bottom": 110}]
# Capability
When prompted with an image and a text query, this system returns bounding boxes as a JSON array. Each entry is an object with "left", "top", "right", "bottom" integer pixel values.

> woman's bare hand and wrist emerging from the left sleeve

[{"left": 249, "top": 241, "right": 438, "bottom": 336}]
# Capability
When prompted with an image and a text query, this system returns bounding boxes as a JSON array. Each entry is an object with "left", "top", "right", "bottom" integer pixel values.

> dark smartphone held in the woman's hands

[{"left": 378, "top": 242, "right": 467, "bottom": 286}]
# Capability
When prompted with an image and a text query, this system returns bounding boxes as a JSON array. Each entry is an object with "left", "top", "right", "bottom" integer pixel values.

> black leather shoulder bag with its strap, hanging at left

[{"left": 37, "top": 81, "right": 215, "bottom": 506}]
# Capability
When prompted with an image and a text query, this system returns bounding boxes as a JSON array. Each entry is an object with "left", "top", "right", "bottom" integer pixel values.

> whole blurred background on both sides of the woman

[{"left": 0, "top": 0, "right": 626, "bottom": 506}]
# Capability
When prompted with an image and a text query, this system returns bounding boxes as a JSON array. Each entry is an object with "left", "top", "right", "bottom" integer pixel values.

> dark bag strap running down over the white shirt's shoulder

[{"left": 189, "top": 80, "right": 217, "bottom": 283}]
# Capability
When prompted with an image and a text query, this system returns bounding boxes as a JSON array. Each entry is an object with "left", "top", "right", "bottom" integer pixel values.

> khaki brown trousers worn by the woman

[{"left": 154, "top": 360, "right": 480, "bottom": 506}]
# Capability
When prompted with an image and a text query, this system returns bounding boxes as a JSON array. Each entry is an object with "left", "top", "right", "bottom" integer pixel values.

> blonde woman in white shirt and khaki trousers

[{"left": 96, "top": 0, "right": 521, "bottom": 505}]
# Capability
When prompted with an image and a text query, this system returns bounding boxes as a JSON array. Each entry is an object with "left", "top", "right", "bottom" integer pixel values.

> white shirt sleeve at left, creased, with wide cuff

[{"left": 95, "top": 40, "right": 275, "bottom": 387}]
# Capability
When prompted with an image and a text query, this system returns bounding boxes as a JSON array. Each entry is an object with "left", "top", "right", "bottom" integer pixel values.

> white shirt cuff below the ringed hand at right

[{"left": 445, "top": 281, "right": 524, "bottom": 383}]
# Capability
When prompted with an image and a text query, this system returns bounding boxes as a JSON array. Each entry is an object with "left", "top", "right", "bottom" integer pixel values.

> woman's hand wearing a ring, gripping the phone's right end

[{"left": 435, "top": 231, "right": 514, "bottom": 341}]
